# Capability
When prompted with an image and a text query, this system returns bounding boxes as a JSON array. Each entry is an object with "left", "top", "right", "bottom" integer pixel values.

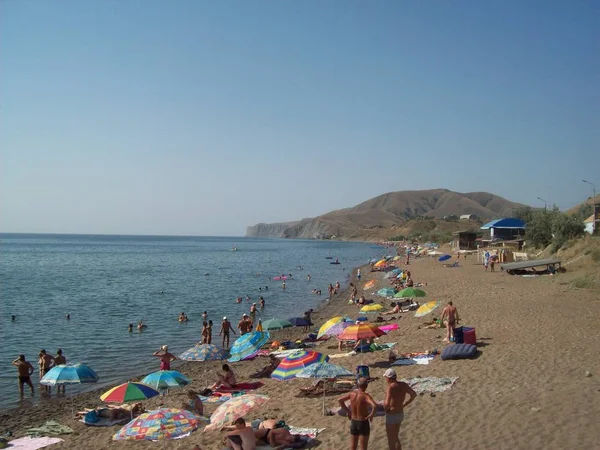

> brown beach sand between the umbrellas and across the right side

[{"left": 0, "top": 258, "right": 600, "bottom": 450}]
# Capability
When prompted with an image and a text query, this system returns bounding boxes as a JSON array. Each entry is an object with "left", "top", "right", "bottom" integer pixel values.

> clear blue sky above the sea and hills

[{"left": 0, "top": 0, "right": 600, "bottom": 235}]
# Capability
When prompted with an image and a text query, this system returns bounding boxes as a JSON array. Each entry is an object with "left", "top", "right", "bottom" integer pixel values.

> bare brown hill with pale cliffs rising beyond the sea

[{"left": 246, "top": 189, "right": 523, "bottom": 240}]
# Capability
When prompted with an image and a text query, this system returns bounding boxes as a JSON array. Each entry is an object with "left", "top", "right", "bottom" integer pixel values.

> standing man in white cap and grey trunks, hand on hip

[{"left": 383, "top": 369, "right": 417, "bottom": 450}]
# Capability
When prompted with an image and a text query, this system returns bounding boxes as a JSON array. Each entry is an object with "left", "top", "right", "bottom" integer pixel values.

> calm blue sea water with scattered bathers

[{"left": 0, "top": 234, "right": 381, "bottom": 408}]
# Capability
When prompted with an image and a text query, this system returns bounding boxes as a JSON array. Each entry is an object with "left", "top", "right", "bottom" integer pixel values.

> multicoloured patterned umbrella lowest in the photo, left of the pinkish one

[{"left": 113, "top": 408, "right": 200, "bottom": 441}]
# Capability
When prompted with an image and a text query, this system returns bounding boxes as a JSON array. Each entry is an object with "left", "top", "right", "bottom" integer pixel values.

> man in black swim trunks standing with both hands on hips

[{"left": 338, "top": 378, "right": 377, "bottom": 450}]
